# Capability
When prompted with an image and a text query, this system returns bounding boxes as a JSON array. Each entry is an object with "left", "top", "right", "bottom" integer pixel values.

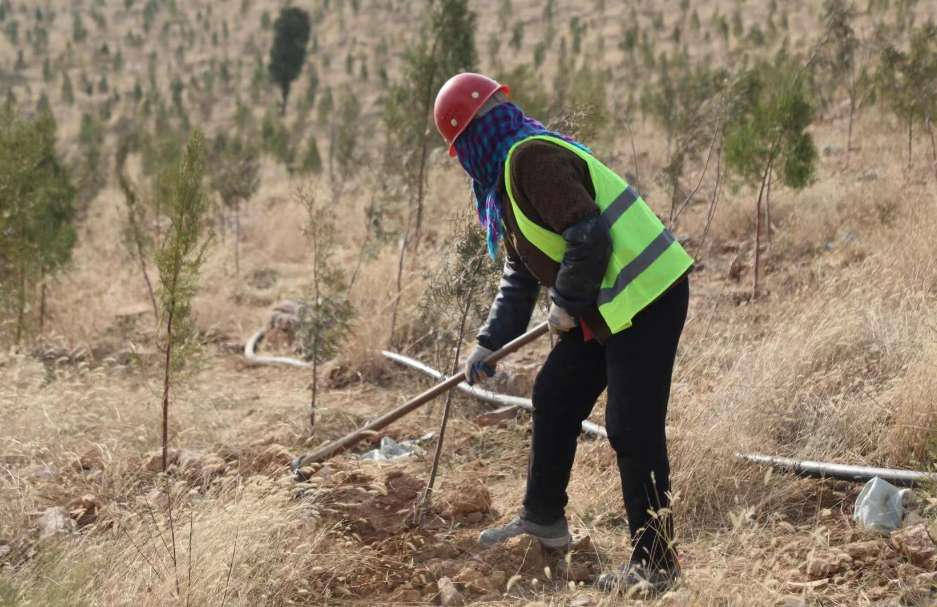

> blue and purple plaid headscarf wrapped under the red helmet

[{"left": 455, "top": 103, "right": 591, "bottom": 259}]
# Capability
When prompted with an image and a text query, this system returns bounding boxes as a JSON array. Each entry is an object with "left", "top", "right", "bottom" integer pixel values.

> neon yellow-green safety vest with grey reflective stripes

[{"left": 504, "top": 135, "right": 693, "bottom": 333}]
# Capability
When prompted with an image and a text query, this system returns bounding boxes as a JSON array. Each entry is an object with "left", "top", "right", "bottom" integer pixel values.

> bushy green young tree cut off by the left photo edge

[{"left": 0, "top": 107, "right": 76, "bottom": 344}]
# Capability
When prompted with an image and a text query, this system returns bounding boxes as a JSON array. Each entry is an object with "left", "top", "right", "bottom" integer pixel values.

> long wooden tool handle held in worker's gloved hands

[{"left": 293, "top": 323, "right": 548, "bottom": 471}]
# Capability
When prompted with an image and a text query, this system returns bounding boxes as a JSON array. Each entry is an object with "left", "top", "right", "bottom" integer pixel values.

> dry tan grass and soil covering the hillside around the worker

[{"left": 0, "top": 0, "right": 937, "bottom": 607}]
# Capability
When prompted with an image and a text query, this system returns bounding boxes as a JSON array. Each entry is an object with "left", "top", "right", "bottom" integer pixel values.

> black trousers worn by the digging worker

[{"left": 523, "top": 279, "right": 690, "bottom": 569}]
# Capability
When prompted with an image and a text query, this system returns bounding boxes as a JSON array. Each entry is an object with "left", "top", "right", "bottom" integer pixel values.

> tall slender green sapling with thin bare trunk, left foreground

[{"left": 156, "top": 131, "right": 210, "bottom": 472}]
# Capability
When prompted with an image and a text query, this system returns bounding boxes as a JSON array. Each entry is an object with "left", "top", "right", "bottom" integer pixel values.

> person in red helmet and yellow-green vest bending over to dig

[{"left": 434, "top": 73, "right": 693, "bottom": 593}]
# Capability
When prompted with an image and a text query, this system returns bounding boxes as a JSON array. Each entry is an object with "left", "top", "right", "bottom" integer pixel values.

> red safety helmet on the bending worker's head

[{"left": 433, "top": 72, "right": 511, "bottom": 156}]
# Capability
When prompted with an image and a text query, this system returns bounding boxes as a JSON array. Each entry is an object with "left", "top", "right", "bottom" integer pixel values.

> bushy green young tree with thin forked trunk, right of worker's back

[{"left": 725, "top": 57, "right": 817, "bottom": 298}]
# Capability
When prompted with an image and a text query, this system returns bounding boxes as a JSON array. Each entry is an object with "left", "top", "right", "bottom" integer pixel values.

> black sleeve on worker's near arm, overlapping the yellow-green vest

[{"left": 551, "top": 216, "right": 612, "bottom": 316}]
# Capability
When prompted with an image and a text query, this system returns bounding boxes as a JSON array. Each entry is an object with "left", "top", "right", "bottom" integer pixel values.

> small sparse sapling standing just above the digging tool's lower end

[{"left": 296, "top": 187, "right": 354, "bottom": 434}]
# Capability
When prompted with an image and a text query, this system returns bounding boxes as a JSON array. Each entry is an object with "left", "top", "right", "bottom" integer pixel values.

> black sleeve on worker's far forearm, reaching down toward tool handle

[{"left": 478, "top": 249, "right": 540, "bottom": 350}]
